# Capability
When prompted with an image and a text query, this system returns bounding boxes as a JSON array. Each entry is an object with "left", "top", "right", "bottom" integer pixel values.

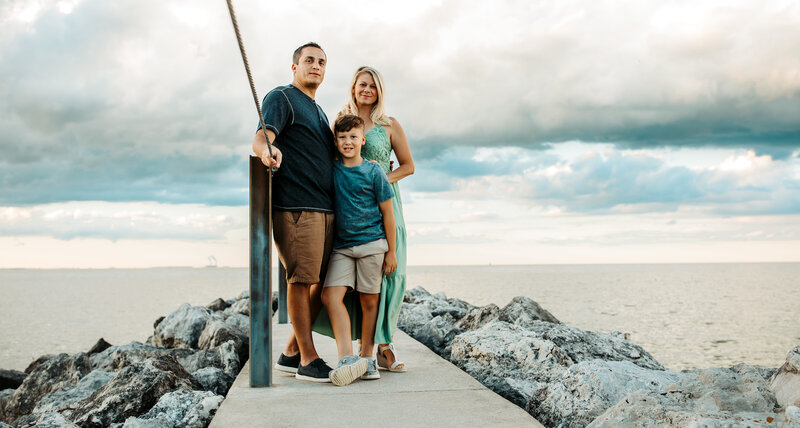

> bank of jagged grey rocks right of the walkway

[{"left": 399, "top": 287, "right": 800, "bottom": 428}]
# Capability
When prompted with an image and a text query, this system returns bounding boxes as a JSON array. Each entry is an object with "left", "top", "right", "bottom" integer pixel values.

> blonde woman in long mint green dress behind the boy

[{"left": 339, "top": 66, "right": 414, "bottom": 372}]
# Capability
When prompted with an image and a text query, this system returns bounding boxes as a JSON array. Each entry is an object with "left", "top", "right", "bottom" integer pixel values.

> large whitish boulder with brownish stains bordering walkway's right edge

[{"left": 450, "top": 321, "right": 574, "bottom": 407}]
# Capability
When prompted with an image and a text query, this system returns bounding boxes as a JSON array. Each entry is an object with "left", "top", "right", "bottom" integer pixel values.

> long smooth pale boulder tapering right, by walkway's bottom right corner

[{"left": 526, "top": 360, "right": 682, "bottom": 427}]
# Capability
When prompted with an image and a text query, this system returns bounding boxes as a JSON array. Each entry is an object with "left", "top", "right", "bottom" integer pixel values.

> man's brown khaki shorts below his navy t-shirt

[{"left": 272, "top": 211, "right": 333, "bottom": 284}]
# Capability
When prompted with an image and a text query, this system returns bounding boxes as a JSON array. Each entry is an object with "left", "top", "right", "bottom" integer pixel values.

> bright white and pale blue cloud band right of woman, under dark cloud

[{"left": 409, "top": 144, "right": 800, "bottom": 216}]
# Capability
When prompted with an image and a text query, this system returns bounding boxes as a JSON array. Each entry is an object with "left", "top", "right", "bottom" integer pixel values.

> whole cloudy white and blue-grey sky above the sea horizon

[{"left": 0, "top": 0, "right": 800, "bottom": 268}]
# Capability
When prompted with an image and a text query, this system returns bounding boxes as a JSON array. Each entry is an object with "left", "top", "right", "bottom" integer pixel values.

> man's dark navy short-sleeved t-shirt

[{"left": 257, "top": 85, "right": 334, "bottom": 213}]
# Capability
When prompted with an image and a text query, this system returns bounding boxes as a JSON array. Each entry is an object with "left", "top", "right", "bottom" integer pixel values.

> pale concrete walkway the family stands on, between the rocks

[{"left": 210, "top": 324, "right": 542, "bottom": 428}]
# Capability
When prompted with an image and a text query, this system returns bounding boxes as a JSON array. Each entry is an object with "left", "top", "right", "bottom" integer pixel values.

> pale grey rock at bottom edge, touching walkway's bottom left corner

[{"left": 124, "top": 390, "right": 224, "bottom": 428}]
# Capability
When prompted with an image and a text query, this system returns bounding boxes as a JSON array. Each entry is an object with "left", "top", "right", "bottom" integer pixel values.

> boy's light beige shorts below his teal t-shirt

[{"left": 325, "top": 239, "right": 389, "bottom": 294}]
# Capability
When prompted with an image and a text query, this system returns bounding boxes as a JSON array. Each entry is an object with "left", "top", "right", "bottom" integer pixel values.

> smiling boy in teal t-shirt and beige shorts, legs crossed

[{"left": 322, "top": 115, "right": 397, "bottom": 386}]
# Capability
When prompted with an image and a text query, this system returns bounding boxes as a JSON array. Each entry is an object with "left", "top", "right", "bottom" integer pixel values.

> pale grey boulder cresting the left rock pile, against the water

[{"left": 154, "top": 303, "right": 211, "bottom": 348}]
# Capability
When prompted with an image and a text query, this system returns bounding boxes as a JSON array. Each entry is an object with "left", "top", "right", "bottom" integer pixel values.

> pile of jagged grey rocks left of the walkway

[{"left": 0, "top": 293, "right": 262, "bottom": 428}]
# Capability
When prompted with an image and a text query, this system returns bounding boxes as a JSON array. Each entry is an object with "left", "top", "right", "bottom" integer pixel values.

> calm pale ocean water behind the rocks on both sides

[{"left": 0, "top": 263, "right": 800, "bottom": 370}]
